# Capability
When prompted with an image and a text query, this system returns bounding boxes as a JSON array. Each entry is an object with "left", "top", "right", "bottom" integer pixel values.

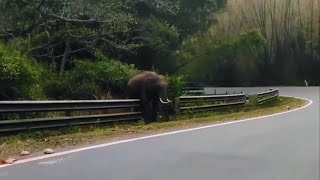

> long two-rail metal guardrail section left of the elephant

[{"left": 0, "top": 99, "right": 141, "bottom": 132}]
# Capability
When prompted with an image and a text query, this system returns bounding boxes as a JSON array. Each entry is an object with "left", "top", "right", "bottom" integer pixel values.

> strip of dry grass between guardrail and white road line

[{"left": 0, "top": 97, "right": 306, "bottom": 157}]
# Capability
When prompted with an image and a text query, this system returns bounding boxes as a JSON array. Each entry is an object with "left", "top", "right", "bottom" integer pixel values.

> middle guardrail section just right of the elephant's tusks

[{"left": 177, "top": 94, "right": 247, "bottom": 112}]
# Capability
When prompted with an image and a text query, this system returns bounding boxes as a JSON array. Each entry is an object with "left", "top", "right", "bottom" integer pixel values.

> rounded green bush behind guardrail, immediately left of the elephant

[{"left": 46, "top": 58, "right": 139, "bottom": 99}]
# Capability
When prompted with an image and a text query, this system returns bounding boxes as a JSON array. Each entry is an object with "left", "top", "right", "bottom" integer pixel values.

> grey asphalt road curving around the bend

[{"left": 0, "top": 87, "right": 319, "bottom": 180}]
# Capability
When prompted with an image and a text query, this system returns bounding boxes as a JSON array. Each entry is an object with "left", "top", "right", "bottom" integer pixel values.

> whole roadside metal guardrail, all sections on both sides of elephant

[{"left": 0, "top": 89, "right": 279, "bottom": 133}]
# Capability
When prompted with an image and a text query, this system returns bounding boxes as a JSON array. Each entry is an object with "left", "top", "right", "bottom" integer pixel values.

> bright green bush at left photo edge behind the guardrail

[{"left": 0, "top": 43, "right": 47, "bottom": 100}]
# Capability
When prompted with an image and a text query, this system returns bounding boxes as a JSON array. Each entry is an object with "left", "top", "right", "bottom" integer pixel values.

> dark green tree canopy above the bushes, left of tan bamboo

[{"left": 0, "top": 0, "right": 224, "bottom": 74}]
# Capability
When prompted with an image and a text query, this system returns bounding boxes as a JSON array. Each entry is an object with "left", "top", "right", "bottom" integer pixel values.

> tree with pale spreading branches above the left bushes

[{"left": 2, "top": 0, "right": 177, "bottom": 75}]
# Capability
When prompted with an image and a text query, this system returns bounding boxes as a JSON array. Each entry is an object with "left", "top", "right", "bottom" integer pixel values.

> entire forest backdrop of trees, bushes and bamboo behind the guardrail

[{"left": 0, "top": 0, "right": 320, "bottom": 100}]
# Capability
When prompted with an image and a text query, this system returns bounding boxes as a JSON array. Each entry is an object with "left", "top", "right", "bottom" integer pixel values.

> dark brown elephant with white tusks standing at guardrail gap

[{"left": 127, "top": 71, "right": 172, "bottom": 123}]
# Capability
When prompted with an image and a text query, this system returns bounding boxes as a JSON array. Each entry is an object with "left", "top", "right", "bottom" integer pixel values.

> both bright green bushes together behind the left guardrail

[{"left": 0, "top": 40, "right": 139, "bottom": 100}]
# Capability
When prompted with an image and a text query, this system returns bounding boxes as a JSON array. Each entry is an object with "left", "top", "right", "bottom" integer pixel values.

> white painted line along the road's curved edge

[{"left": 0, "top": 96, "right": 313, "bottom": 169}]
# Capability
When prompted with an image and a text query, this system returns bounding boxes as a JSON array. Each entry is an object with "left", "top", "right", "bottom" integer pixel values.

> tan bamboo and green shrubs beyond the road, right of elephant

[{"left": 179, "top": 0, "right": 320, "bottom": 86}]
